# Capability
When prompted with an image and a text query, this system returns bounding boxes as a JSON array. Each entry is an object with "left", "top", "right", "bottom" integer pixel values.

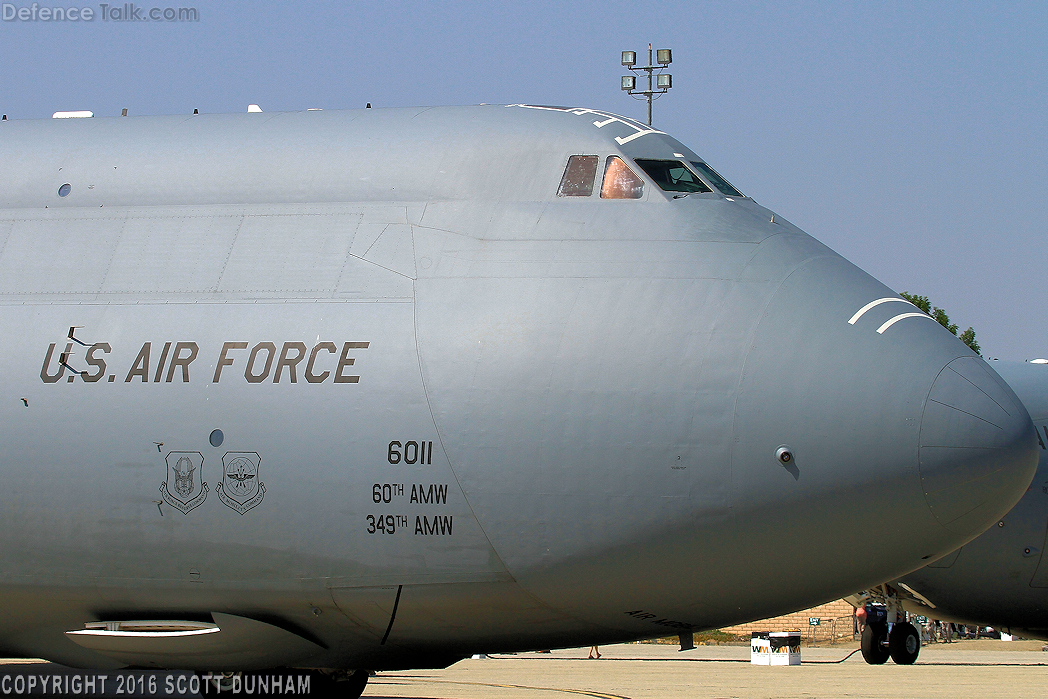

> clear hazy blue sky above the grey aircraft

[{"left": 0, "top": 0, "right": 1048, "bottom": 359}]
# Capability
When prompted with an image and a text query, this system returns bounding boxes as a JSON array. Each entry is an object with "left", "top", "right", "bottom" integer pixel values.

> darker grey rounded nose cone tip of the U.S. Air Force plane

[{"left": 918, "top": 357, "right": 1036, "bottom": 533}]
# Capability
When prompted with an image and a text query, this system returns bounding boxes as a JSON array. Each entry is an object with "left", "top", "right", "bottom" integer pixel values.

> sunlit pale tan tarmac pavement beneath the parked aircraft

[{"left": 364, "top": 639, "right": 1048, "bottom": 699}]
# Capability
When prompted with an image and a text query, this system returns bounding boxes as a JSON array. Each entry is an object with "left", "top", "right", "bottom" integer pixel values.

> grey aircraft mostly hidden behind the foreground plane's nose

[{"left": 855, "top": 362, "right": 1048, "bottom": 661}]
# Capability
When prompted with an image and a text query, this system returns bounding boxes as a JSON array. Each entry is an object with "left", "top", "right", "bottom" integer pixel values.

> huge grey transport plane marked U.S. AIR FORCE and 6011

[{"left": 0, "top": 105, "right": 1038, "bottom": 686}]
